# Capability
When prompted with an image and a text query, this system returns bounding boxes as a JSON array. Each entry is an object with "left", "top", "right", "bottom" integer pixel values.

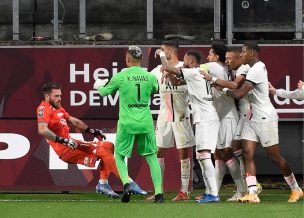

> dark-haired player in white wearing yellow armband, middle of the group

[{"left": 203, "top": 43, "right": 246, "bottom": 201}]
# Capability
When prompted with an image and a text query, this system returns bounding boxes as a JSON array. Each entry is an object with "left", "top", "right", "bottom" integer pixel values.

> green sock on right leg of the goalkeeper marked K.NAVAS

[{"left": 145, "top": 154, "right": 162, "bottom": 195}]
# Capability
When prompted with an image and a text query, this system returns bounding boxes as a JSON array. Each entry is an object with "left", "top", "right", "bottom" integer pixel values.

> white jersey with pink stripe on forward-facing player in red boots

[{"left": 151, "top": 61, "right": 189, "bottom": 122}]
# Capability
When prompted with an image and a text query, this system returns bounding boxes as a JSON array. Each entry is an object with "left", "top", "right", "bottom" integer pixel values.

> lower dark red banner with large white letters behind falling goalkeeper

[{"left": 0, "top": 120, "right": 188, "bottom": 192}]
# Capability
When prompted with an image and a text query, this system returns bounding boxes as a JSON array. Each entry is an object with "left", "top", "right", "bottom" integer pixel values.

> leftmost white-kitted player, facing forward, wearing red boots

[{"left": 148, "top": 41, "right": 195, "bottom": 201}]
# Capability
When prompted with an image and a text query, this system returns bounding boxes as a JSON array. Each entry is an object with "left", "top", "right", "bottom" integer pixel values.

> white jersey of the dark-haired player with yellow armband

[{"left": 207, "top": 62, "right": 239, "bottom": 119}]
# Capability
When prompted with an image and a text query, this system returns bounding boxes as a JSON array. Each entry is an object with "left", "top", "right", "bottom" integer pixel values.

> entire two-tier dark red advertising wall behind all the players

[{"left": 0, "top": 45, "right": 304, "bottom": 191}]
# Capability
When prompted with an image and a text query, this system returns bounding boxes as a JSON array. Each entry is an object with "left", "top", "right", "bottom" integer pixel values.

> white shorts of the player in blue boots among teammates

[{"left": 195, "top": 120, "right": 220, "bottom": 153}]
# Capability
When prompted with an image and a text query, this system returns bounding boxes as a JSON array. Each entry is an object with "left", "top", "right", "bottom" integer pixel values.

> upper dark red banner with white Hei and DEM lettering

[{"left": 0, "top": 45, "right": 304, "bottom": 119}]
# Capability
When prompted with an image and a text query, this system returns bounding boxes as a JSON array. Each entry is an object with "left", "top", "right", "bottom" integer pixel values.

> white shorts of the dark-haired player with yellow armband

[{"left": 216, "top": 118, "right": 237, "bottom": 149}]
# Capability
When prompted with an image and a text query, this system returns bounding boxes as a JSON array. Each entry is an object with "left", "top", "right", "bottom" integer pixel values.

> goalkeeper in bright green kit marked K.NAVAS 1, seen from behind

[{"left": 94, "top": 46, "right": 164, "bottom": 203}]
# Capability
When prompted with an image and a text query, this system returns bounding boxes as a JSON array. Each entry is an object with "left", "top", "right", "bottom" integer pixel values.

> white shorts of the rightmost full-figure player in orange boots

[{"left": 242, "top": 120, "right": 279, "bottom": 147}]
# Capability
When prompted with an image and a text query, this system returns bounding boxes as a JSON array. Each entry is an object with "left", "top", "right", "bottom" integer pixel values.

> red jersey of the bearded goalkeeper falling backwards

[{"left": 37, "top": 101, "right": 70, "bottom": 155}]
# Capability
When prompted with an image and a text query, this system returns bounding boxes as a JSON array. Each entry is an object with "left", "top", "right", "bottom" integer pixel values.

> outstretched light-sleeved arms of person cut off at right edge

[{"left": 268, "top": 80, "right": 304, "bottom": 100}]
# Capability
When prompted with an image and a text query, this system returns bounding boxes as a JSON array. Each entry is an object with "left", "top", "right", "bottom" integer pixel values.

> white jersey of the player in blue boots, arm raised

[{"left": 182, "top": 68, "right": 219, "bottom": 123}]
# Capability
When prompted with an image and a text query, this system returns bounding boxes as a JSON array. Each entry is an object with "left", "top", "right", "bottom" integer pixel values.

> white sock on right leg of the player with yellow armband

[{"left": 226, "top": 157, "right": 246, "bottom": 193}]
